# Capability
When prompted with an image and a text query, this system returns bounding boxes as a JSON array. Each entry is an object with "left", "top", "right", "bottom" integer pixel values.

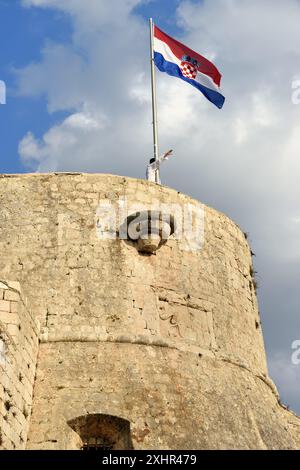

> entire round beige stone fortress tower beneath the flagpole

[{"left": 0, "top": 173, "right": 300, "bottom": 450}]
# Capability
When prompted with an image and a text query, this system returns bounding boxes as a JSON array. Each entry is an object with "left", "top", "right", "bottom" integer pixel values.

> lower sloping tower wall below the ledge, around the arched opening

[{"left": 28, "top": 341, "right": 300, "bottom": 450}]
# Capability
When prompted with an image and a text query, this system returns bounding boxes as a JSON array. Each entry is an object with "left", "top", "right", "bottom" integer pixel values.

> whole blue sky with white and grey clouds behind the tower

[{"left": 0, "top": 0, "right": 300, "bottom": 412}]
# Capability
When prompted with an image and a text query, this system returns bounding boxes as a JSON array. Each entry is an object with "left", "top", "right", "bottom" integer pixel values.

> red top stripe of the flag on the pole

[{"left": 154, "top": 25, "right": 222, "bottom": 86}]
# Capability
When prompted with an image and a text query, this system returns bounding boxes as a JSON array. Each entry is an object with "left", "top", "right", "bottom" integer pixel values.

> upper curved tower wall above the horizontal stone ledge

[{"left": 0, "top": 174, "right": 266, "bottom": 374}]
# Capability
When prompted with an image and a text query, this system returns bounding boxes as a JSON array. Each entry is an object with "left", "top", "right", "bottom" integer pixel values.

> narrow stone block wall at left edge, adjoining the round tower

[{"left": 0, "top": 281, "right": 38, "bottom": 449}]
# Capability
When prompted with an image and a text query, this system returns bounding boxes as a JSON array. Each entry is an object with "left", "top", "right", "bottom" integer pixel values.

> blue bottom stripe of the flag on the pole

[{"left": 154, "top": 52, "right": 225, "bottom": 109}]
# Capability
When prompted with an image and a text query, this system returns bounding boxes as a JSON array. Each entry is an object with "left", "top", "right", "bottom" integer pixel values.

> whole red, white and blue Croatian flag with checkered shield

[{"left": 154, "top": 25, "right": 225, "bottom": 109}]
